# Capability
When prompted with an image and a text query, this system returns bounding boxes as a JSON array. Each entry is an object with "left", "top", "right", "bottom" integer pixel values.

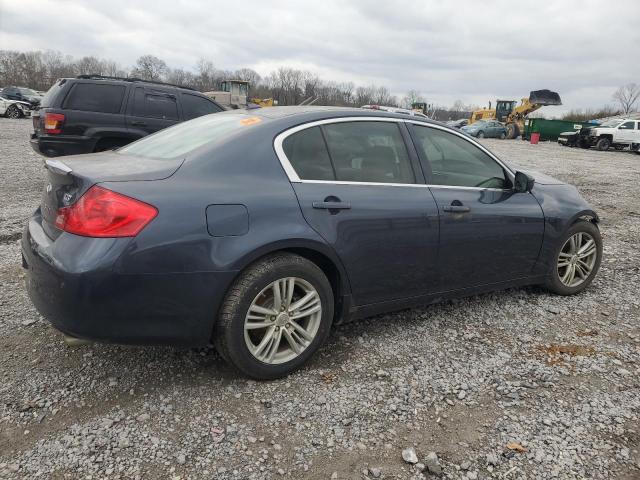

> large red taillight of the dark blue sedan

[{"left": 56, "top": 185, "right": 158, "bottom": 237}]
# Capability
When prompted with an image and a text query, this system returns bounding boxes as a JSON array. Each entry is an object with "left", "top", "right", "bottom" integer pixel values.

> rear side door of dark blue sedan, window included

[{"left": 276, "top": 117, "right": 438, "bottom": 305}]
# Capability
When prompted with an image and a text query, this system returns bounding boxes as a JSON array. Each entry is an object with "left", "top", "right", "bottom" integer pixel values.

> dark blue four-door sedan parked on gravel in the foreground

[{"left": 22, "top": 107, "right": 602, "bottom": 379}]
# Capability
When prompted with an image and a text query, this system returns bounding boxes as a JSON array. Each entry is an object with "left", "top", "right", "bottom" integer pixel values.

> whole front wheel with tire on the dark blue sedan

[{"left": 546, "top": 221, "right": 602, "bottom": 295}]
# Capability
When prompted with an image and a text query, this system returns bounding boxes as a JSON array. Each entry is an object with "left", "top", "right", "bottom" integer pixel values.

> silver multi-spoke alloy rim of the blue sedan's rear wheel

[{"left": 244, "top": 277, "right": 322, "bottom": 364}]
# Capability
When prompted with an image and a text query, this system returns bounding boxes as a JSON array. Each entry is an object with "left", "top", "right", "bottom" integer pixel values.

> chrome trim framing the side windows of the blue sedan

[{"left": 273, "top": 117, "right": 514, "bottom": 192}]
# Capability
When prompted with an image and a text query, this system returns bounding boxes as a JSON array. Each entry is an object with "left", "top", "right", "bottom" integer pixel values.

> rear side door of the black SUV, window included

[{"left": 127, "top": 86, "right": 180, "bottom": 137}]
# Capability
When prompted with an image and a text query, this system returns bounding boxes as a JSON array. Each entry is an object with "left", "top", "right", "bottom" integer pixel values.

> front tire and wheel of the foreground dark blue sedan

[{"left": 545, "top": 221, "right": 602, "bottom": 295}]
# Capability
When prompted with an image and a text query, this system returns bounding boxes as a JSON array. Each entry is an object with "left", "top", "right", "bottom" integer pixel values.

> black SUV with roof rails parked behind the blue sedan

[{"left": 31, "top": 75, "right": 224, "bottom": 157}]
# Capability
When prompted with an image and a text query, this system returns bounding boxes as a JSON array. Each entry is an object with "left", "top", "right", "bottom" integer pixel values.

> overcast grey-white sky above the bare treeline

[{"left": 0, "top": 0, "right": 640, "bottom": 113}]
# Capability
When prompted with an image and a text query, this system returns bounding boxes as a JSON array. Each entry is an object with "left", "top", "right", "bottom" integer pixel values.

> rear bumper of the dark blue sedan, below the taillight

[{"left": 22, "top": 212, "right": 236, "bottom": 346}]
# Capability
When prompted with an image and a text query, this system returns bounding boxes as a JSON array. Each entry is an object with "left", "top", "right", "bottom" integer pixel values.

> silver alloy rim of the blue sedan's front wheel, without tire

[{"left": 557, "top": 232, "right": 598, "bottom": 287}]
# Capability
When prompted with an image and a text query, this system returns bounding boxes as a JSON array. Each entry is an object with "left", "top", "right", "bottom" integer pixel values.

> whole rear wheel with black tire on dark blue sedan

[{"left": 214, "top": 253, "right": 334, "bottom": 380}]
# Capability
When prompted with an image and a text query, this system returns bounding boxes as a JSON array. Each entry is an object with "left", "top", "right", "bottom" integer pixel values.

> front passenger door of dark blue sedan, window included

[{"left": 411, "top": 124, "right": 544, "bottom": 290}]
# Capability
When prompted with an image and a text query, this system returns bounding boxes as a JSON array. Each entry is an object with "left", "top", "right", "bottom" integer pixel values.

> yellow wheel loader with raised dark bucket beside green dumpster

[{"left": 469, "top": 90, "right": 562, "bottom": 138}]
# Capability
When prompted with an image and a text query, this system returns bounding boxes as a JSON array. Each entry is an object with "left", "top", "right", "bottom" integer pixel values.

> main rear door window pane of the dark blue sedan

[{"left": 322, "top": 121, "right": 415, "bottom": 183}]
